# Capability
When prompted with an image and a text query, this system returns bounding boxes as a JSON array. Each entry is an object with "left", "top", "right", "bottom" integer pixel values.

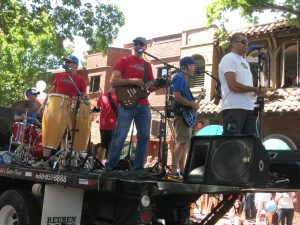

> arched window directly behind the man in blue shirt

[{"left": 190, "top": 55, "right": 205, "bottom": 88}]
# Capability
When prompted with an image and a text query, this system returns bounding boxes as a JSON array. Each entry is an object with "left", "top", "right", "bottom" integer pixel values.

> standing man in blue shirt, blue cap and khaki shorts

[{"left": 170, "top": 56, "right": 203, "bottom": 175}]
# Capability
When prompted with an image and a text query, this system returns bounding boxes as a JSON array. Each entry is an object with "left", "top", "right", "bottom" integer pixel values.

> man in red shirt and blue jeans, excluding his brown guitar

[{"left": 106, "top": 37, "right": 158, "bottom": 170}]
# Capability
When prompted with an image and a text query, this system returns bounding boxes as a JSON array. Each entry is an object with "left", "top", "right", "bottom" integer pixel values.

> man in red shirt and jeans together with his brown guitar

[{"left": 106, "top": 37, "right": 162, "bottom": 170}]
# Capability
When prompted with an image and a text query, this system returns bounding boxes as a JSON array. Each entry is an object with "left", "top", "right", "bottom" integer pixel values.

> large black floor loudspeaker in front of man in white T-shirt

[{"left": 184, "top": 135, "right": 269, "bottom": 187}]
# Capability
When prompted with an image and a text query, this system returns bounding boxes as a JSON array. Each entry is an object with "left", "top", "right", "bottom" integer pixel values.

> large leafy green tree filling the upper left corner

[{"left": 0, "top": 0, "right": 125, "bottom": 106}]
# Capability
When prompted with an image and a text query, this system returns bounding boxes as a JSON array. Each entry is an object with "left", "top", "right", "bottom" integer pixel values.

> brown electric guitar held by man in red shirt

[{"left": 115, "top": 79, "right": 156, "bottom": 109}]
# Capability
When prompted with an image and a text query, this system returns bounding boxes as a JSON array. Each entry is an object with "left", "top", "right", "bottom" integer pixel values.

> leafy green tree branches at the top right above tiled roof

[{"left": 207, "top": 0, "right": 300, "bottom": 44}]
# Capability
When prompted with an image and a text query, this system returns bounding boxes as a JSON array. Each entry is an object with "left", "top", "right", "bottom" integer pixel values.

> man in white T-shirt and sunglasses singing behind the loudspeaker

[{"left": 218, "top": 32, "right": 265, "bottom": 135}]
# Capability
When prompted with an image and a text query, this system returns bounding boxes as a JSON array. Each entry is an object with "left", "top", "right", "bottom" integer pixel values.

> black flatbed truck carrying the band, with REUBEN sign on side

[{"left": 0, "top": 165, "right": 258, "bottom": 225}]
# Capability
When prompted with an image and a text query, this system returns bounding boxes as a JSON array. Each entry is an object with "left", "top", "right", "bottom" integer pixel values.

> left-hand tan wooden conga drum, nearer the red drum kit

[{"left": 42, "top": 94, "right": 71, "bottom": 149}]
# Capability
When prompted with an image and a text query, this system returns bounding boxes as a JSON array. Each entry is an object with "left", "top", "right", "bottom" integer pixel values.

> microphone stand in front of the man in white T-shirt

[{"left": 254, "top": 49, "right": 264, "bottom": 140}]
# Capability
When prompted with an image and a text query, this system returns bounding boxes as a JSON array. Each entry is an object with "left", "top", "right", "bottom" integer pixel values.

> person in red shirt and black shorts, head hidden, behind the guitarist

[{"left": 96, "top": 92, "right": 118, "bottom": 161}]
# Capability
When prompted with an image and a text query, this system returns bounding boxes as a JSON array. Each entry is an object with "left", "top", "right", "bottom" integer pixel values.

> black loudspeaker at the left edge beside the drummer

[{"left": 0, "top": 107, "right": 14, "bottom": 147}]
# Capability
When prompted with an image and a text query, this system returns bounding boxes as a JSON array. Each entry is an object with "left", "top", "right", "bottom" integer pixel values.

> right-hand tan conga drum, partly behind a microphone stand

[{"left": 68, "top": 100, "right": 91, "bottom": 152}]
